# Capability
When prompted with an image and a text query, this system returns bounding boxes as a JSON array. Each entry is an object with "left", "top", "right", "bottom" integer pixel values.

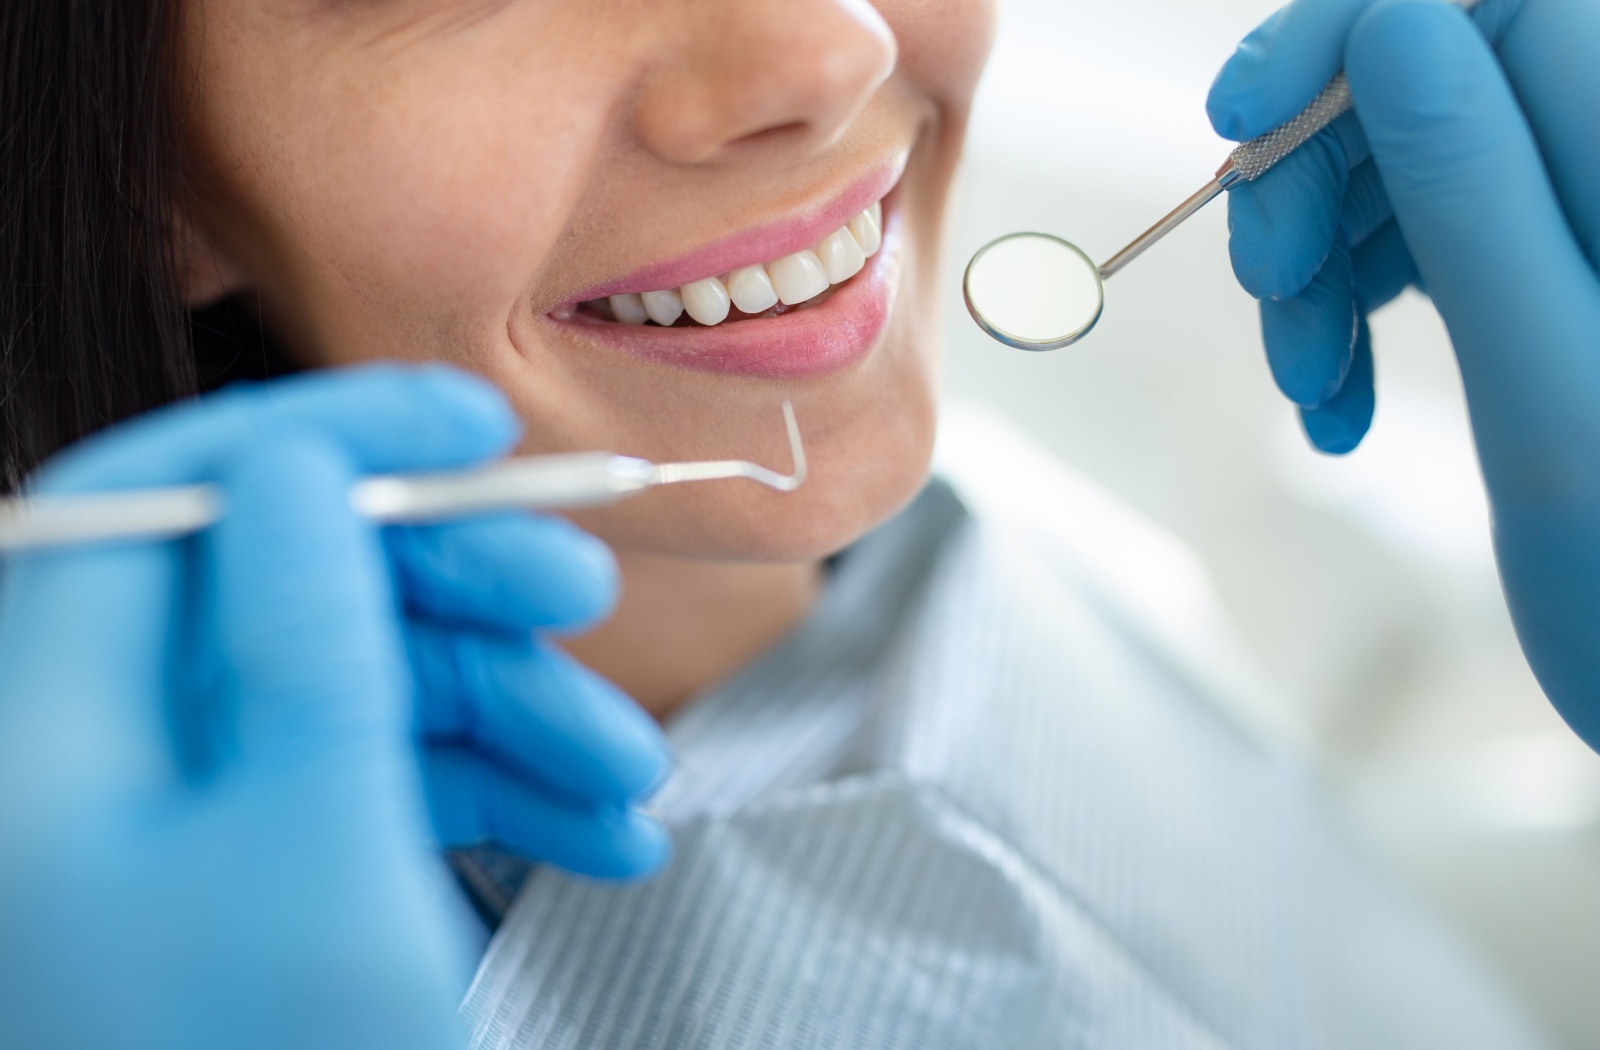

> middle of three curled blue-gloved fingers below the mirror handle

[{"left": 1261, "top": 238, "right": 1358, "bottom": 408}]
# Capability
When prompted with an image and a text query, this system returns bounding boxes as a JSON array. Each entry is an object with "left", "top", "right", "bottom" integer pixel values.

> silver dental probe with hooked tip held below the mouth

[{"left": 0, "top": 402, "right": 806, "bottom": 551}]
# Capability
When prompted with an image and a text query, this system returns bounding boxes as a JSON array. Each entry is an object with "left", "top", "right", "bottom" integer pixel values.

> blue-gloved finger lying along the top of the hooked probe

[{"left": 37, "top": 365, "right": 520, "bottom": 491}]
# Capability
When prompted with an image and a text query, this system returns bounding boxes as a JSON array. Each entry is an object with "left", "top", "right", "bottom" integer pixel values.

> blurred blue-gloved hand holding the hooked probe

[{"left": 0, "top": 368, "right": 667, "bottom": 1050}]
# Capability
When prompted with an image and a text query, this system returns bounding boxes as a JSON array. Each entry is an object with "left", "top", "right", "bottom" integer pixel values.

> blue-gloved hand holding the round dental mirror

[{"left": 1210, "top": 0, "right": 1600, "bottom": 747}]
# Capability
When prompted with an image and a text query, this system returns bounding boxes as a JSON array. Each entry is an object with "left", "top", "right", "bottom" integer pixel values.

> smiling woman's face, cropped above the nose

[{"left": 181, "top": 0, "right": 992, "bottom": 560}]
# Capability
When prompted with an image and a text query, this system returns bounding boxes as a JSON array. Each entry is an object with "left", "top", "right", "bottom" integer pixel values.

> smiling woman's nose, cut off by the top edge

[{"left": 635, "top": 0, "right": 898, "bottom": 163}]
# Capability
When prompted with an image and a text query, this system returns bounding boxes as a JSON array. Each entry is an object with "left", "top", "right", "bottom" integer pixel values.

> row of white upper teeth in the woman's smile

[{"left": 611, "top": 203, "right": 883, "bottom": 327}]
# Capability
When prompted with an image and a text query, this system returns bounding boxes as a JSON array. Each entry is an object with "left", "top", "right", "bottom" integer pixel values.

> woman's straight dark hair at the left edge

[{"left": 0, "top": 0, "right": 292, "bottom": 491}]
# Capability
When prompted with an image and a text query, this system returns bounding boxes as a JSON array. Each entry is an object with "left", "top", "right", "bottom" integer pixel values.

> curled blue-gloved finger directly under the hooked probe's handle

[{"left": 384, "top": 514, "right": 618, "bottom": 635}]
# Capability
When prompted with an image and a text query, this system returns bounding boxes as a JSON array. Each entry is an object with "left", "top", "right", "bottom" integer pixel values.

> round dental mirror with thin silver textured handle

[{"left": 962, "top": 0, "right": 1482, "bottom": 351}]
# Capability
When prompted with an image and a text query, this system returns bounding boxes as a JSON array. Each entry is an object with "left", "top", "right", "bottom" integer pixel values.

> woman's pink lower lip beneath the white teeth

[{"left": 547, "top": 206, "right": 901, "bottom": 379}]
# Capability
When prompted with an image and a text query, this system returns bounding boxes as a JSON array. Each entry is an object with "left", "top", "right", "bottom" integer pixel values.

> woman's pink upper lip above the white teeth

[{"left": 550, "top": 155, "right": 906, "bottom": 306}]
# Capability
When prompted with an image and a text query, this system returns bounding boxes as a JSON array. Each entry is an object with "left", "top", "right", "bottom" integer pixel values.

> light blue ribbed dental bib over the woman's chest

[{"left": 464, "top": 408, "right": 1544, "bottom": 1050}]
